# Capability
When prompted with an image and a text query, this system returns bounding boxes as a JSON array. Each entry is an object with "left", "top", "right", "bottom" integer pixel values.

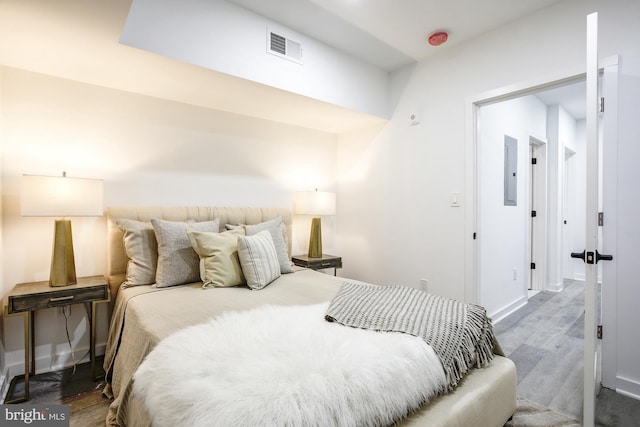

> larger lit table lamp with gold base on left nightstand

[{"left": 20, "top": 172, "right": 103, "bottom": 286}]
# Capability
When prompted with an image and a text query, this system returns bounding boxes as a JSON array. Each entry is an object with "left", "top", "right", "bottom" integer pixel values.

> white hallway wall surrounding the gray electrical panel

[{"left": 477, "top": 96, "right": 547, "bottom": 317}]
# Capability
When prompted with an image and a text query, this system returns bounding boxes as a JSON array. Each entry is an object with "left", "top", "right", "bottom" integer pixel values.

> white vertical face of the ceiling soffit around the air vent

[{"left": 121, "top": 0, "right": 389, "bottom": 118}]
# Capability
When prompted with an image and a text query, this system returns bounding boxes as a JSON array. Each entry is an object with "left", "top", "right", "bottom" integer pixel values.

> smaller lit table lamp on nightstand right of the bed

[{"left": 294, "top": 189, "right": 336, "bottom": 258}]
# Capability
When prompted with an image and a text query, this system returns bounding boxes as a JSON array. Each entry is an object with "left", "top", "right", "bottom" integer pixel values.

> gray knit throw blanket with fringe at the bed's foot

[{"left": 325, "top": 282, "right": 494, "bottom": 392}]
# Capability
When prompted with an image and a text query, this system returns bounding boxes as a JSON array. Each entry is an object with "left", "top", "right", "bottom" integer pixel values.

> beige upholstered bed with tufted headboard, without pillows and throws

[{"left": 104, "top": 207, "right": 516, "bottom": 427}]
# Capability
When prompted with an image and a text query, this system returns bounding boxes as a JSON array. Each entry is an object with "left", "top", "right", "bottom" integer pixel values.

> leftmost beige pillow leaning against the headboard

[{"left": 116, "top": 219, "right": 158, "bottom": 287}]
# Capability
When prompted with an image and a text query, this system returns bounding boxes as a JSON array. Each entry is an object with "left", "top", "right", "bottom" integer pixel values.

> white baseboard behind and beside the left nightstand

[{"left": 0, "top": 343, "right": 107, "bottom": 402}]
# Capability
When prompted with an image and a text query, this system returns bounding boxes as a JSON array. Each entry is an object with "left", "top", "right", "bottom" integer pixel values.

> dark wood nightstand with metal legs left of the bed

[{"left": 4, "top": 276, "right": 111, "bottom": 403}]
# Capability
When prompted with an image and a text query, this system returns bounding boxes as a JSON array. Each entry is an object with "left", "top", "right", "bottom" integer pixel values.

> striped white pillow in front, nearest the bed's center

[{"left": 238, "top": 230, "right": 280, "bottom": 289}]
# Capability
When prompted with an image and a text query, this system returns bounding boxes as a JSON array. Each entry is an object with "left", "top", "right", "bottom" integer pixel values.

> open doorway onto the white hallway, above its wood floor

[{"left": 472, "top": 76, "right": 585, "bottom": 320}]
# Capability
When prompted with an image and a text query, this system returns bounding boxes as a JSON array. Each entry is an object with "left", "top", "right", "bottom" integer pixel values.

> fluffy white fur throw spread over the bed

[{"left": 134, "top": 303, "right": 446, "bottom": 427}]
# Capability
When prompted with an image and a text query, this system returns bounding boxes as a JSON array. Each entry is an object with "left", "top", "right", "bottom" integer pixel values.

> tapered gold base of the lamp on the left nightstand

[{"left": 49, "top": 219, "right": 77, "bottom": 286}]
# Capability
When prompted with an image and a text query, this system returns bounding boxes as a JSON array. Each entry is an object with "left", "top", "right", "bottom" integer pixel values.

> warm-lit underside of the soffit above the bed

[{"left": 0, "top": 0, "right": 384, "bottom": 133}]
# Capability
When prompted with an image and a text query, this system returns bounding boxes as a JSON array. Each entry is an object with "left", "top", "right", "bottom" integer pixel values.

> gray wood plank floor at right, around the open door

[{"left": 494, "top": 281, "right": 640, "bottom": 427}]
